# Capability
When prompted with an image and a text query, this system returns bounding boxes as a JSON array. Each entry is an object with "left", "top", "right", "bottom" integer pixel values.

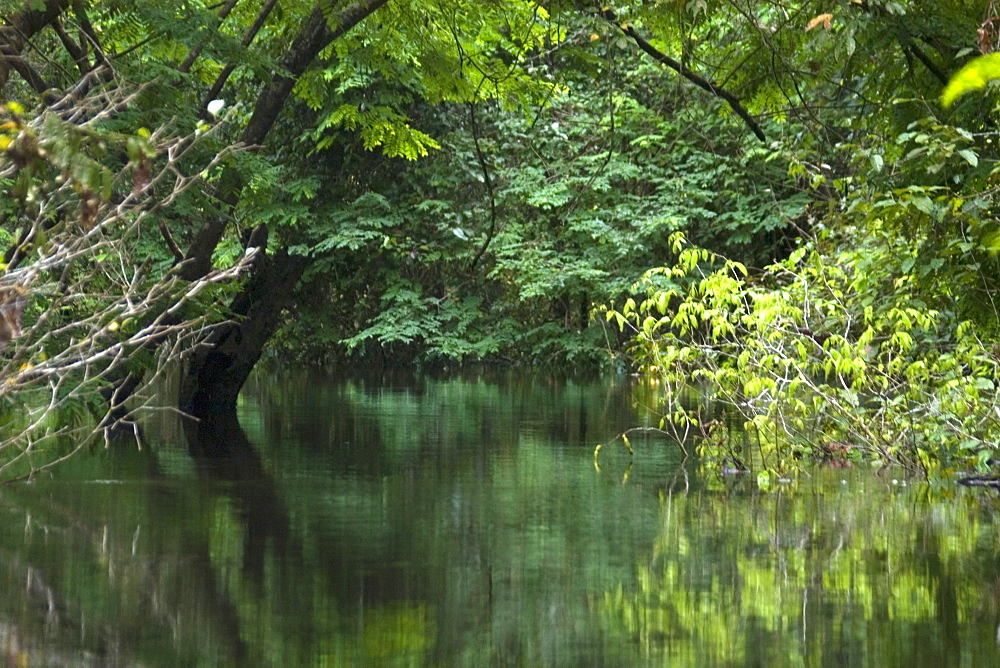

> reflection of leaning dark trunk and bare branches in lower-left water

[{"left": 0, "top": 408, "right": 320, "bottom": 665}]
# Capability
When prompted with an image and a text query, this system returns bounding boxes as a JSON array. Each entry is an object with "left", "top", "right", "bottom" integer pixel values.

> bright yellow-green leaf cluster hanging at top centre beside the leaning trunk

[{"left": 296, "top": 0, "right": 559, "bottom": 160}]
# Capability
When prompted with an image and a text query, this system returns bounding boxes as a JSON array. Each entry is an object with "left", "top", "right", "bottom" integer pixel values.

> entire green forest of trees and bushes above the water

[{"left": 0, "top": 0, "right": 1000, "bottom": 486}]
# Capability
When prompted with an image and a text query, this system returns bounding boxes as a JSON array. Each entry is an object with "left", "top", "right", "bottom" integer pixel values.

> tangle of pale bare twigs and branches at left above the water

[{"left": 0, "top": 86, "right": 258, "bottom": 480}]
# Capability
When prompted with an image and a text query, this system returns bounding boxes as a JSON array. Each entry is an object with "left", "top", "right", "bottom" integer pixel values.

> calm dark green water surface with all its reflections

[{"left": 0, "top": 373, "right": 1000, "bottom": 666}]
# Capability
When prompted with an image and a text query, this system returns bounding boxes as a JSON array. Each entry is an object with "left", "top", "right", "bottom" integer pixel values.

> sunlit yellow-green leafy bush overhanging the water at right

[{"left": 606, "top": 227, "right": 1000, "bottom": 475}]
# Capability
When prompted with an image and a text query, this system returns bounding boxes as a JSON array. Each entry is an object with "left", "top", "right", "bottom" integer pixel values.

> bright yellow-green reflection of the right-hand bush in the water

[{"left": 595, "top": 475, "right": 1000, "bottom": 666}]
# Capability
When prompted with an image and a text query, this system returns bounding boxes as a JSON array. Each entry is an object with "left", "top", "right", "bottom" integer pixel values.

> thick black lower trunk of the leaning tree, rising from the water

[{"left": 179, "top": 227, "right": 309, "bottom": 419}]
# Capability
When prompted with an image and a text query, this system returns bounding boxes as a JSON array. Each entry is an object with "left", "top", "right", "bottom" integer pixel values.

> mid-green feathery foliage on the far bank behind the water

[{"left": 276, "top": 59, "right": 804, "bottom": 364}]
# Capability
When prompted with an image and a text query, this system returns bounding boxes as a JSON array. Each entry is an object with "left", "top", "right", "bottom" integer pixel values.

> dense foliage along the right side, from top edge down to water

[{"left": 607, "top": 3, "right": 1000, "bottom": 486}]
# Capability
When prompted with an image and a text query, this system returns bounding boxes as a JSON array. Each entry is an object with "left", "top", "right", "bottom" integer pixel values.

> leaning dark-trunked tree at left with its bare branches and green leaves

[{"left": 0, "top": 0, "right": 564, "bottom": 468}]
